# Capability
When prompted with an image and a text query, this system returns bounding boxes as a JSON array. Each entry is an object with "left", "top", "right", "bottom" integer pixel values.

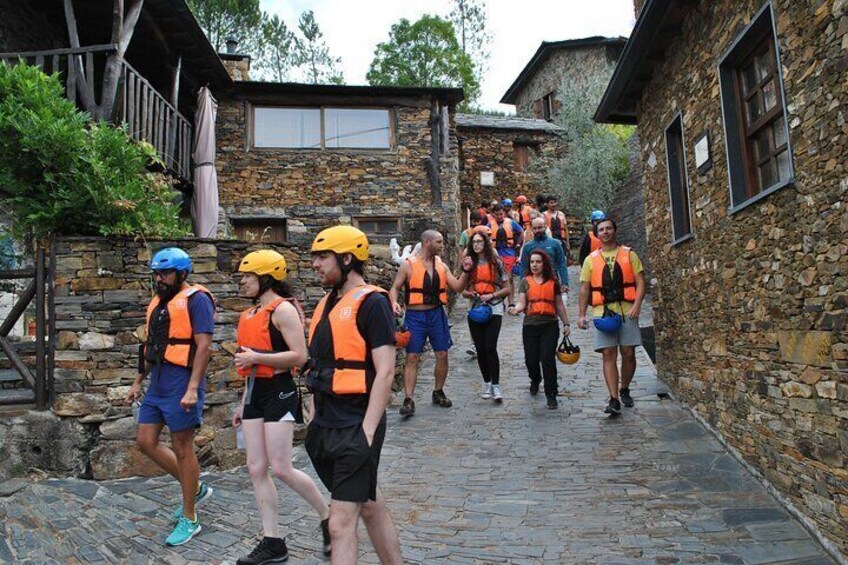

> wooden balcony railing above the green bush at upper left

[{"left": 0, "top": 45, "right": 192, "bottom": 180}]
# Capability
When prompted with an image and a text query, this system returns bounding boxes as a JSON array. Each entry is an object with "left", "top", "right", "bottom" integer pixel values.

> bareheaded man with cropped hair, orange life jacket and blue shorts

[{"left": 389, "top": 230, "right": 471, "bottom": 416}]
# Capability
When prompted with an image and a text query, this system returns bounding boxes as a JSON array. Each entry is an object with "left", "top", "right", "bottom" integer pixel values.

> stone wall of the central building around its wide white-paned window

[{"left": 217, "top": 99, "right": 459, "bottom": 251}]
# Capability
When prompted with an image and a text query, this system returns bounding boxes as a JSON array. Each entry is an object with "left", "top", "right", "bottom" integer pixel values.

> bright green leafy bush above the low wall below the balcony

[{"left": 0, "top": 63, "right": 185, "bottom": 238}]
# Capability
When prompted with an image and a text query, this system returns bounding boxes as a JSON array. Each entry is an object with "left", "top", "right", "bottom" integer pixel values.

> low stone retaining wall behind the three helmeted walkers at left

[{"left": 0, "top": 238, "right": 396, "bottom": 479}]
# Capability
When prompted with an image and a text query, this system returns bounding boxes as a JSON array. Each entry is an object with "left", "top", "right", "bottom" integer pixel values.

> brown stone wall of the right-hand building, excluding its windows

[{"left": 639, "top": 0, "right": 848, "bottom": 553}]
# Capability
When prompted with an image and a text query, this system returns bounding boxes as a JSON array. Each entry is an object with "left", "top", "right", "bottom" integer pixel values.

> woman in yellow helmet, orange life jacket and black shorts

[{"left": 233, "top": 249, "right": 330, "bottom": 565}]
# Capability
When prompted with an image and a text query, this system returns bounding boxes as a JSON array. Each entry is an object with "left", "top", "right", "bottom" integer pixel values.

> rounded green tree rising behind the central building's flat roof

[{"left": 366, "top": 15, "right": 480, "bottom": 105}]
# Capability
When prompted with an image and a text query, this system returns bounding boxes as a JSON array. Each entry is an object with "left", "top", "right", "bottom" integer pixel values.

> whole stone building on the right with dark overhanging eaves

[{"left": 596, "top": 0, "right": 848, "bottom": 556}]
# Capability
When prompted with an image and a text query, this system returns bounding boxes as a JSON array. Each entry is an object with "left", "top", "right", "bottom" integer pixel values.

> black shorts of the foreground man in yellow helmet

[{"left": 306, "top": 416, "right": 386, "bottom": 502}]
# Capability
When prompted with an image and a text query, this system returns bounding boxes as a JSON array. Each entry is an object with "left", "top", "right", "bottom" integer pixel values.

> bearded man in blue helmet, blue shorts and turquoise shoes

[{"left": 125, "top": 247, "right": 215, "bottom": 545}]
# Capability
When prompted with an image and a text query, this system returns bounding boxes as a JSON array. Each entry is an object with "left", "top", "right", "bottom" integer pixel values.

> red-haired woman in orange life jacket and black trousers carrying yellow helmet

[{"left": 509, "top": 249, "right": 571, "bottom": 410}]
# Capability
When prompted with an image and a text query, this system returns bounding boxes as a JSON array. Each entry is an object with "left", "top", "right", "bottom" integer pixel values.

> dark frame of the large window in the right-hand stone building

[{"left": 718, "top": 1, "right": 795, "bottom": 215}]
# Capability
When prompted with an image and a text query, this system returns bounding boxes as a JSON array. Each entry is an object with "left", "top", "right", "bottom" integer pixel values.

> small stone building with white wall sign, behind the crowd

[{"left": 456, "top": 114, "right": 562, "bottom": 218}]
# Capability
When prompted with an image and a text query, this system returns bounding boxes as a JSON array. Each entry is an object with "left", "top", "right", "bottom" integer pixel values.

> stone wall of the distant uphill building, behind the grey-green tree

[{"left": 515, "top": 46, "right": 618, "bottom": 118}]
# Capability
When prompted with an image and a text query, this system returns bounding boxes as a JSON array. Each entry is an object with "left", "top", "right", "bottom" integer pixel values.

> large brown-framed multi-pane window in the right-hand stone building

[{"left": 719, "top": 4, "right": 794, "bottom": 212}]
